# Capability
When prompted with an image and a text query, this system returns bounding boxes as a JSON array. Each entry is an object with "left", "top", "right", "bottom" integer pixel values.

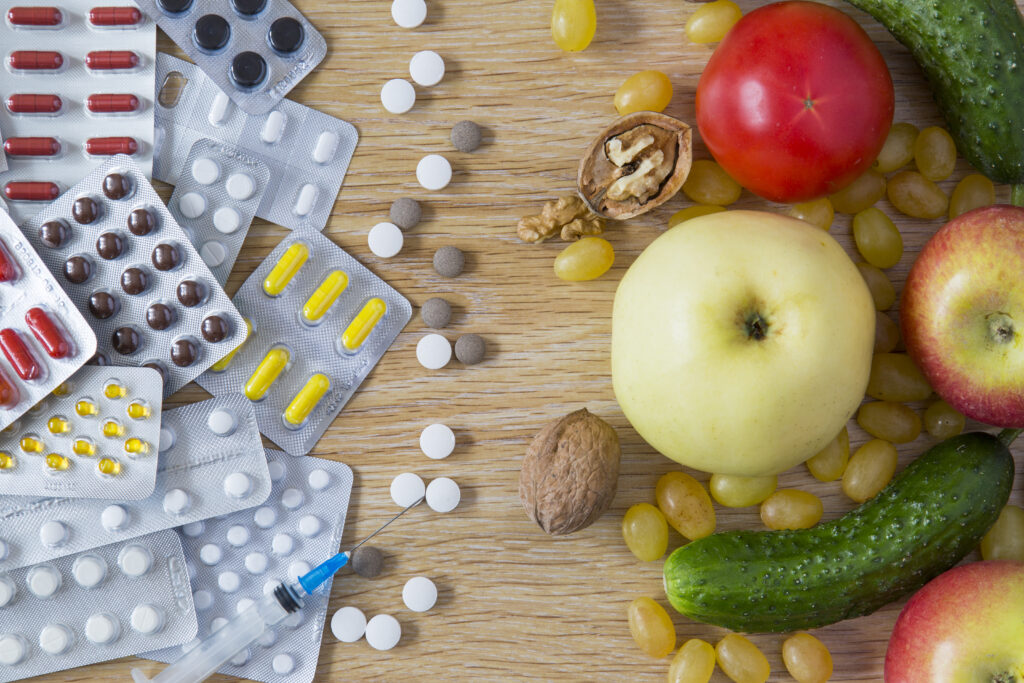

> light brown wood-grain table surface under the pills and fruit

[{"left": 38, "top": 0, "right": 1024, "bottom": 681}]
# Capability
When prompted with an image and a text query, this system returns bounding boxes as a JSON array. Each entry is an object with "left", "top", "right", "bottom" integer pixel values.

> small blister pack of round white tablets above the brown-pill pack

[{"left": 167, "top": 138, "right": 270, "bottom": 285}]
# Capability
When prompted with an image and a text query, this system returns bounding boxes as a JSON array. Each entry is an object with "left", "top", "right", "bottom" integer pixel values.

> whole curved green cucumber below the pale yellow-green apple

[{"left": 665, "top": 430, "right": 1016, "bottom": 632}]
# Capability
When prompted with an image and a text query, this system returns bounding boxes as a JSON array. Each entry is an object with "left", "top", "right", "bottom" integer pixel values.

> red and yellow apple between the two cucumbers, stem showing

[{"left": 900, "top": 206, "right": 1024, "bottom": 427}]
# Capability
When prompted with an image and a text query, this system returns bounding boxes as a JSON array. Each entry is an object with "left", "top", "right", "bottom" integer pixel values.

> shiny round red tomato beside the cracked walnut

[{"left": 696, "top": 0, "right": 893, "bottom": 202}]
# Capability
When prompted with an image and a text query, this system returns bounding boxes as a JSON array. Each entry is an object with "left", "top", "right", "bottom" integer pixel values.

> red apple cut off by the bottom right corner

[{"left": 885, "top": 561, "right": 1024, "bottom": 683}]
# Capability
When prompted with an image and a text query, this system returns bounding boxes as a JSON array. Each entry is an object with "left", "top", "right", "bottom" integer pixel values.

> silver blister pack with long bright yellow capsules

[{"left": 197, "top": 230, "right": 413, "bottom": 456}]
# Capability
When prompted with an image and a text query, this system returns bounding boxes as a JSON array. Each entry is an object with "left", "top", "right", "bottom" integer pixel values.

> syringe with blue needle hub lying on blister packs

[{"left": 131, "top": 498, "right": 423, "bottom": 683}]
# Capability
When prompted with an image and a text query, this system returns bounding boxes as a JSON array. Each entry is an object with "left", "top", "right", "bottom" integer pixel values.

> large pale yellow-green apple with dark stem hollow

[{"left": 611, "top": 211, "right": 874, "bottom": 476}]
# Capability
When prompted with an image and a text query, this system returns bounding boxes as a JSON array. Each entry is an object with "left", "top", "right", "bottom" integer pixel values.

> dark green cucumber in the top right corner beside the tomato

[{"left": 847, "top": 0, "right": 1024, "bottom": 189}]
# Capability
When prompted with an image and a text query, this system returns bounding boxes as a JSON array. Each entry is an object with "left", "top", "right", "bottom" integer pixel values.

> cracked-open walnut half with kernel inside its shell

[{"left": 577, "top": 112, "right": 692, "bottom": 220}]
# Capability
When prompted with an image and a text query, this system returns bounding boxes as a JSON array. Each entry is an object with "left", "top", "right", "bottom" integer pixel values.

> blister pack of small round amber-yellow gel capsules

[{"left": 0, "top": 366, "right": 163, "bottom": 500}]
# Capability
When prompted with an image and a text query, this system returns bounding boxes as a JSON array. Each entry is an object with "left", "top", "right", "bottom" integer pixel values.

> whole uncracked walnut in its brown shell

[{"left": 519, "top": 409, "right": 622, "bottom": 536}]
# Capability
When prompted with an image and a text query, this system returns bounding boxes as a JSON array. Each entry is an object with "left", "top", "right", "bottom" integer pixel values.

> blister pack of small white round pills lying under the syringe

[{"left": 140, "top": 450, "right": 352, "bottom": 683}]
